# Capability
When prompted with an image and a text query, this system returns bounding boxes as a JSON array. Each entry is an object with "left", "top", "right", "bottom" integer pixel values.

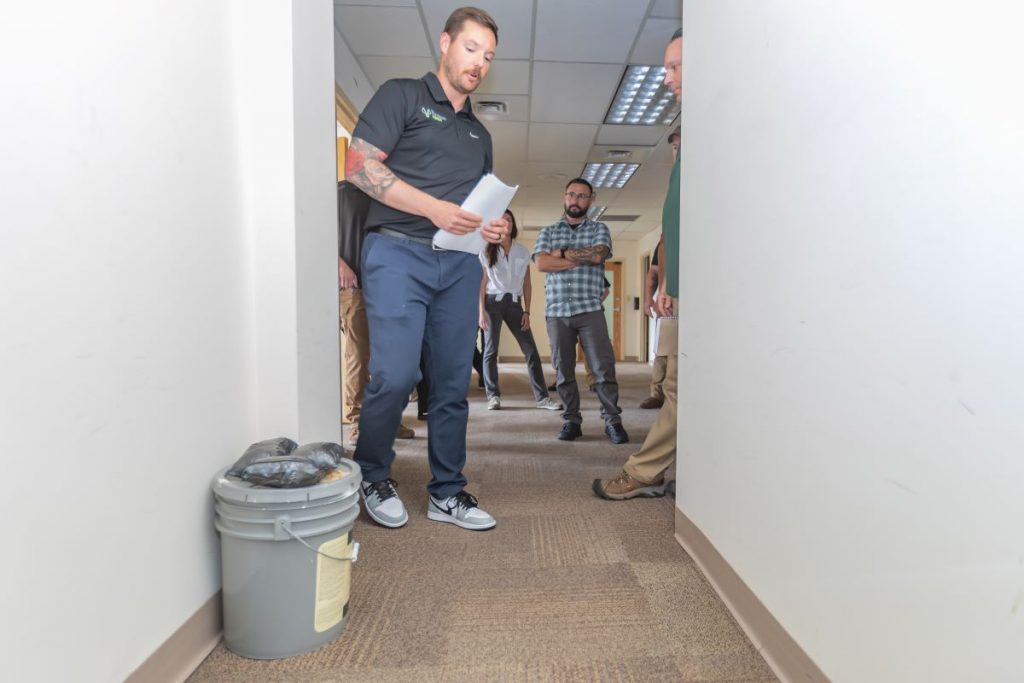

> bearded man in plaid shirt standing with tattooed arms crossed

[{"left": 534, "top": 178, "right": 630, "bottom": 443}]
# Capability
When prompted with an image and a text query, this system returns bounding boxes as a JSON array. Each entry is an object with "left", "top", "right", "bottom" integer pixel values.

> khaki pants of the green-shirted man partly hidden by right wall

[{"left": 623, "top": 313, "right": 679, "bottom": 483}]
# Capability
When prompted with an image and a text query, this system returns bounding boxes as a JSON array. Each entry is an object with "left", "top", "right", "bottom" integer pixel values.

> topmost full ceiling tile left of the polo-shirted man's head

[{"left": 334, "top": 5, "right": 433, "bottom": 57}]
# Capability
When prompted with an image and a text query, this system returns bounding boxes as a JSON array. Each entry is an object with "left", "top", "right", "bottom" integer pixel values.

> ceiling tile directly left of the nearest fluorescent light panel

[{"left": 530, "top": 61, "right": 623, "bottom": 123}]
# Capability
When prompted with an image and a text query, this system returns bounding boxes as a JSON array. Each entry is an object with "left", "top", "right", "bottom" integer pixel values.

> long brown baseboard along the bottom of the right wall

[{"left": 676, "top": 508, "right": 828, "bottom": 683}]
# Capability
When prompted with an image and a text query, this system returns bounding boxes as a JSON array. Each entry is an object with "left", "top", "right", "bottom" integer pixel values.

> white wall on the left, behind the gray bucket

[{"left": 0, "top": 0, "right": 339, "bottom": 681}]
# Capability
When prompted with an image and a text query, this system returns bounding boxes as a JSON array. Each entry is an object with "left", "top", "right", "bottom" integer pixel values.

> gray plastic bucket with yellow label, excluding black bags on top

[{"left": 213, "top": 460, "right": 362, "bottom": 659}]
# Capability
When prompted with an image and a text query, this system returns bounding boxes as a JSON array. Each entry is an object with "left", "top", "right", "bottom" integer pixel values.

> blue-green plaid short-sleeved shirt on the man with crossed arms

[{"left": 532, "top": 216, "right": 611, "bottom": 317}]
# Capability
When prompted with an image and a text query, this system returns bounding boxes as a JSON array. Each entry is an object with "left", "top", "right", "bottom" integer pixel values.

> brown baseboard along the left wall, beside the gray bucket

[{"left": 125, "top": 591, "right": 223, "bottom": 683}]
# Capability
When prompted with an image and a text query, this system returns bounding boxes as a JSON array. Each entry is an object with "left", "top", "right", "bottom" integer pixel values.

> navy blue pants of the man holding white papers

[{"left": 354, "top": 232, "right": 481, "bottom": 498}]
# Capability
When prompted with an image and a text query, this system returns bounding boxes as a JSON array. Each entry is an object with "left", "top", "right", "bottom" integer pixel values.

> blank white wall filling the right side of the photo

[{"left": 678, "top": 0, "right": 1024, "bottom": 683}]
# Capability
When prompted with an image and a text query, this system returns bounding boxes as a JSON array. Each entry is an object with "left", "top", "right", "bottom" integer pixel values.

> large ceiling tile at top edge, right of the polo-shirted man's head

[{"left": 534, "top": 0, "right": 647, "bottom": 63}]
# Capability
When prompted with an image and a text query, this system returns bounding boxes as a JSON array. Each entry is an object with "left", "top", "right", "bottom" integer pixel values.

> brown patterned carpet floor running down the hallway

[{"left": 189, "top": 364, "right": 776, "bottom": 683}]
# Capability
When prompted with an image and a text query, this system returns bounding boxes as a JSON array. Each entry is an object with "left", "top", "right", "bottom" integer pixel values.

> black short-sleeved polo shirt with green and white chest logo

[{"left": 352, "top": 74, "right": 493, "bottom": 238}]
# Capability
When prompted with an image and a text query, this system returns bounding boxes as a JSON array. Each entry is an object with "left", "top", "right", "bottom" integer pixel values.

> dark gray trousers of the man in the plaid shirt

[{"left": 547, "top": 310, "right": 623, "bottom": 425}]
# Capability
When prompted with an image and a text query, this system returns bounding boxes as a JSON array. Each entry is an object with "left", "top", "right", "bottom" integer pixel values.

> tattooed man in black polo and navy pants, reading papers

[{"left": 345, "top": 7, "right": 509, "bottom": 529}]
